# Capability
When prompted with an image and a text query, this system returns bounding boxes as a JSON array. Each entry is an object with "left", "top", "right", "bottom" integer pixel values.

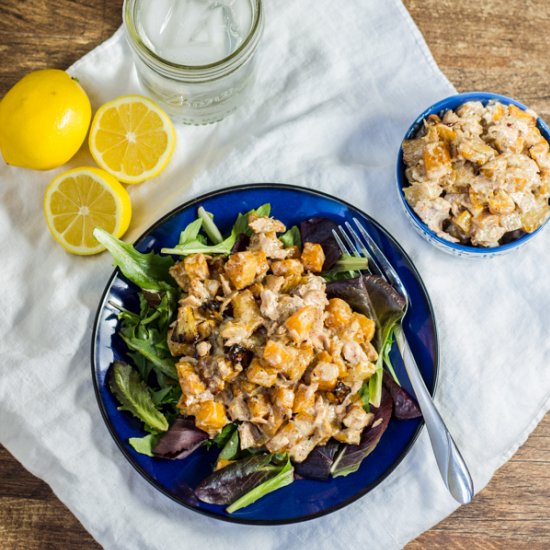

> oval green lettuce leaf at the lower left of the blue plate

[{"left": 109, "top": 361, "right": 168, "bottom": 432}]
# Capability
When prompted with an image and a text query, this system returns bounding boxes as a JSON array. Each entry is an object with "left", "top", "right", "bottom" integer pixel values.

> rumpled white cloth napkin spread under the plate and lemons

[{"left": 0, "top": 0, "right": 550, "bottom": 550}]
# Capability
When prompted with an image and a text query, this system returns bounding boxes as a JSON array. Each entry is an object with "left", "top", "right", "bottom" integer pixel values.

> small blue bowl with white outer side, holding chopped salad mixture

[{"left": 396, "top": 92, "right": 550, "bottom": 259}]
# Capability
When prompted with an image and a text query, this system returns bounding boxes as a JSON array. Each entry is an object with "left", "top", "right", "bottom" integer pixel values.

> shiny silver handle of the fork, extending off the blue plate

[{"left": 395, "top": 325, "right": 474, "bottom": 504}]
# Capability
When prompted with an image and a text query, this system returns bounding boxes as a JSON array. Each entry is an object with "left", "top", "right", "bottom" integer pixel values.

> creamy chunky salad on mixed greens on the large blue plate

[{"left": 95, "top": 204, "right": 420, "bottom": 513}]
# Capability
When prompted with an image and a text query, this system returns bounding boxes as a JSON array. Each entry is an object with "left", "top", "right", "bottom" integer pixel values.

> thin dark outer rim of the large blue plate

[{"left": 90, "top": 183, "right": 440, "bottom": 526}]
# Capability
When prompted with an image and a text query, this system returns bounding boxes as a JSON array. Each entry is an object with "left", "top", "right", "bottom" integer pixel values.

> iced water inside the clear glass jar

[{"left": 139, "top": 0, "right": 253, "bottom": 66}]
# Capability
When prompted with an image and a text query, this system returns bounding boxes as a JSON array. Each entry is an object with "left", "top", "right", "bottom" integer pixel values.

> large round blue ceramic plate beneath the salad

[{"left": 92, "top": 184, "right": 438, "bottom": 524}]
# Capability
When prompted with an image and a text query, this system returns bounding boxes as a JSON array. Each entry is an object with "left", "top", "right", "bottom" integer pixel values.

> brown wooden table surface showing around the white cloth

[{"left": 0, "top": 0, "right": 550, "bottom": 550}]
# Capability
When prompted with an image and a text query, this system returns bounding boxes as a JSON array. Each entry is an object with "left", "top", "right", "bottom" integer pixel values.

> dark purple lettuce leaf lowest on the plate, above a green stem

[{"left": 195, "top": 454, "right": 278, "bottom": 505}]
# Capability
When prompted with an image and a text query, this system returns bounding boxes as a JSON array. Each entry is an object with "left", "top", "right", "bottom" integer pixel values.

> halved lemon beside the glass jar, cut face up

[{"left": 89, "top": 95, "right": 176, "bottom": 183}]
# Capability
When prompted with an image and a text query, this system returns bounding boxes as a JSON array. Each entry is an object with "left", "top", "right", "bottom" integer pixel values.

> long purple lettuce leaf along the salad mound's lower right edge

[{"left": 331, "top": 389, "right": 393, "bottom": 477}]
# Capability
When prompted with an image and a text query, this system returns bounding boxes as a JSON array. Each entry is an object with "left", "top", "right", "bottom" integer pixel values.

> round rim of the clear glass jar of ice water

[{"left": 122, "top": 0, "right": 262, "bottom": 76}]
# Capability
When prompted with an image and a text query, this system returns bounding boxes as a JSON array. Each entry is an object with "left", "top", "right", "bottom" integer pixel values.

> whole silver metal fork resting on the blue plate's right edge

[{"left": 332, "top": 218, "right": 474, "bottom": 504}]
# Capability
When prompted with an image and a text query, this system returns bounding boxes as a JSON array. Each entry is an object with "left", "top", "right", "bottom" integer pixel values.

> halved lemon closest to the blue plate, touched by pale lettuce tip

[{"left": 44, "top": 167, "right": 132, "bottom": 256}]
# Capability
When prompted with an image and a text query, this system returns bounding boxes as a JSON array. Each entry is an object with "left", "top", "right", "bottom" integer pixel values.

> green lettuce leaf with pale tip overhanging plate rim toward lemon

[{"left": 94, "top": 227, "right": 174, "bottom": 291}]
